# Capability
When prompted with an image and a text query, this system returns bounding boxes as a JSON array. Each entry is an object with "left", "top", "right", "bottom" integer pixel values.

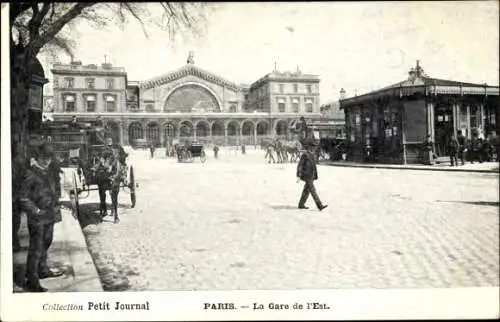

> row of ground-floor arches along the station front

[{"left": 122, "top": 119, "right": 295, "bottom": 146}]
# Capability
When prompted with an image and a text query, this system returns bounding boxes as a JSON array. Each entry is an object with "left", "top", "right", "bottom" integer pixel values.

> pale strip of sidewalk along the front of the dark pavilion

[{"left": 321, "top": 161, "right": 499, "bottom": 173}]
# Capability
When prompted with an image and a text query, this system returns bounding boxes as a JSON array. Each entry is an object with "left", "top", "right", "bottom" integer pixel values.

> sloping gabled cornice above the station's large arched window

[{"left": 139, "top": 64, "right": 241, "bottom": 91}]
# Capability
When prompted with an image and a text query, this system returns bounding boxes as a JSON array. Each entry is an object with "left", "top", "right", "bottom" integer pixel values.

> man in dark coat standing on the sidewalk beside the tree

[{"left": 19, "top": 143, "right": 63, "bottom": 292}]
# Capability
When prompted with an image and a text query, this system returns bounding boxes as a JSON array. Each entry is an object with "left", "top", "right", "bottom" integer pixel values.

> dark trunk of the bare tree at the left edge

[{"left": 10, "top": 53, "right": 31, "bottom": 205}]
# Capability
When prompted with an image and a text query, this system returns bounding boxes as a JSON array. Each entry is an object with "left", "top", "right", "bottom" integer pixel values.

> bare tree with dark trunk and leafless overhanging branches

[{"left": 10, "top": 2, "right": 207, "bottom": 197}]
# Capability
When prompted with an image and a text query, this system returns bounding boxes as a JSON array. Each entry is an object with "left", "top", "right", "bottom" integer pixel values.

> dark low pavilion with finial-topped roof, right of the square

[{"left": 340, "top": 61, "right": 499, "bottom": 164}]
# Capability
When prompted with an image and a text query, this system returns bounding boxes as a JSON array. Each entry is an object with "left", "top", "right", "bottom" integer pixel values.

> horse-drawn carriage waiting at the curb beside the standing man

[{"left": 41, "top": 123, "right": 137, "bottom": 223}]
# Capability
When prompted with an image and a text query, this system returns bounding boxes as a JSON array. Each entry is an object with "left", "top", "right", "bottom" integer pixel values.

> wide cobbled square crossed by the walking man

[{"left": 79, "top": 151, "right": 499, "bottom": 291}]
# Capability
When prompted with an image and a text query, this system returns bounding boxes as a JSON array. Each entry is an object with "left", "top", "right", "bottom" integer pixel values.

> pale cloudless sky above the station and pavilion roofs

[{"left": 41, "top": 1, "right": 499, "bottom": 103}]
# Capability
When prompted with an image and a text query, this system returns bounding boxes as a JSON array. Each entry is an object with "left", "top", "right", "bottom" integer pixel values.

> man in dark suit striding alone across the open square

[{"left": 297, "top": 143, "right": 328, "bottom": 211}]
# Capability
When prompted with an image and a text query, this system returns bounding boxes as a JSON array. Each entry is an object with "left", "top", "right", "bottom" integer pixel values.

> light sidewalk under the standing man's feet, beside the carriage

[{"left": 13, "top": 209, "right": 102, "bottom": 293}]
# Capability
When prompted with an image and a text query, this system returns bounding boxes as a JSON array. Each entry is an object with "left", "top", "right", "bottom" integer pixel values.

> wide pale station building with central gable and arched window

[{"left": 52, "top": 56, "right": 332, "bottom": 145}]
